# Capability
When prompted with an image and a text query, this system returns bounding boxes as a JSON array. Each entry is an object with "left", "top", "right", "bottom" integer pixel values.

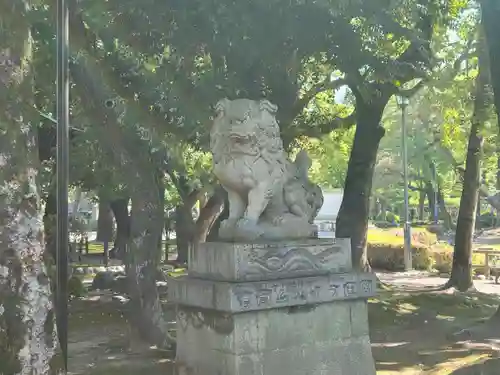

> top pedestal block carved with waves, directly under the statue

[{"left": 189, "top": 238, "right": 352, "bottom": 281}]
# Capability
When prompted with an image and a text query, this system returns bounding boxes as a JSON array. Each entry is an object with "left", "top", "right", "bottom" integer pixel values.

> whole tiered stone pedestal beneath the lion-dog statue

[{"left": 168, "top": 240, "right": 376, "bottom": 375}]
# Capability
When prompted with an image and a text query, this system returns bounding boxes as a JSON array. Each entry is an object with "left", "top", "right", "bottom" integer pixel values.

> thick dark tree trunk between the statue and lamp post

[{"left": 335, "top": 96, "right": 387, "bottom": 270}]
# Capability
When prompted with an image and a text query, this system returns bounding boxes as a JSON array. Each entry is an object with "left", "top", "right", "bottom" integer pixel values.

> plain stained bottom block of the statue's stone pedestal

[{"left": 177, "top": 301, "right": 375, "bottom": 375}]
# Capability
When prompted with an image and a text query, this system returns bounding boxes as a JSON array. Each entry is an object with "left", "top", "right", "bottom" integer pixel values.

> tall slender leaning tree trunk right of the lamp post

[{"left": 447, "top": 30, "right": 489, "bottom": 291}]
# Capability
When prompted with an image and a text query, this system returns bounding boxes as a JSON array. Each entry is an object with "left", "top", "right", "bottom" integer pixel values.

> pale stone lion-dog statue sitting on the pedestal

[{"left": 210, "top": 99, "right": 323, "bottom": 241}]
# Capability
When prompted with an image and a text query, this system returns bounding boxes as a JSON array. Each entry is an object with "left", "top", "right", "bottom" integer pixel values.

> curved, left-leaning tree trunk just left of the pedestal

[{"left": 70, "top": 60, "right": 172, "bottom": 347}]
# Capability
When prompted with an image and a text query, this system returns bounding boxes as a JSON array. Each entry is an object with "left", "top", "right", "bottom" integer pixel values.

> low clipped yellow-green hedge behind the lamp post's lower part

[{"left": 367, "top": 242, "right": 433, "bottom": 271}]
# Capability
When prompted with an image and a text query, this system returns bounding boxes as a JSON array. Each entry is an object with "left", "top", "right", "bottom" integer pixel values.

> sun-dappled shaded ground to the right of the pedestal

[{"left": 369, "top": 291, "right": 500, "bottom": 375}]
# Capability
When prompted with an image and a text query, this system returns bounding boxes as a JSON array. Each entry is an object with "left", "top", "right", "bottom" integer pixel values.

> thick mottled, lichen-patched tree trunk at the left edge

[{"left": 0, "top": 8, "right": 61, "bottom": 375}]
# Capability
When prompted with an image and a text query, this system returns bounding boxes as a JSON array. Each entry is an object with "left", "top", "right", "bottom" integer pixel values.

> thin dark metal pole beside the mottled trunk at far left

[{"left": 56, "top": 0, "right": 69, "bottom": 371}]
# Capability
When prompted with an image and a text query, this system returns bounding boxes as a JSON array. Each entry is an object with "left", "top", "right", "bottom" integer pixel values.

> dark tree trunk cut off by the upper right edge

[{"left": 481, "top": 0, "right": 500, "bottom": 319}]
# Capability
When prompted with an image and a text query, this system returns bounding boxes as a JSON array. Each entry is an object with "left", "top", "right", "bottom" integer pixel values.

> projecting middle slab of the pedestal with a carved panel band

[{"left": 168, "top": 273, "right": 376, "bottom": 312}]
